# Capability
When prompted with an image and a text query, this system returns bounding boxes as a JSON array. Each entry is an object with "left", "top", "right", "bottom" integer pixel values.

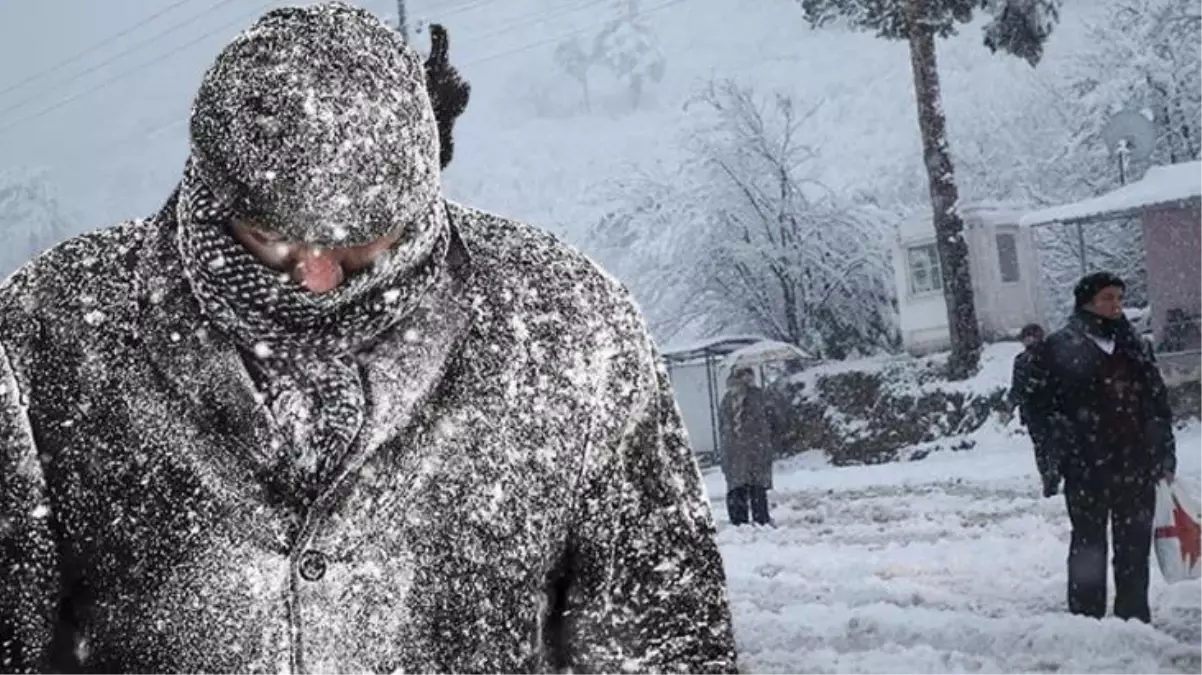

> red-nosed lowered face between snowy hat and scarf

[{"left": 233, "top": 220, "right": 400, "bottom": 293}]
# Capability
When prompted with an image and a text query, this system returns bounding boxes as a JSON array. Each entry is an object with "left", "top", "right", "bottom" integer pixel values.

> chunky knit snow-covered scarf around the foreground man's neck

[{"left": 177, "top": 163, "right": 450, "bottom": 500}]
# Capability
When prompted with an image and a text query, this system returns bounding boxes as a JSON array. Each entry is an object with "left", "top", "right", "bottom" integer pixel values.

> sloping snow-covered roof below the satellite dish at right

[{"left": 1019, "top": 161, "right": 1202, "bottom": 227}]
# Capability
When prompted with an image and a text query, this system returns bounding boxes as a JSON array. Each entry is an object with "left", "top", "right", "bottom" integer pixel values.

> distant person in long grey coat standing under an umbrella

[{"left": 719, "top": 366, "right": 780, "bottom": 525}]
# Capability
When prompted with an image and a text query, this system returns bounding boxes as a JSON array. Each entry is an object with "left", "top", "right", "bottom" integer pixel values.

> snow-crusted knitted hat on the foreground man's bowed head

[{"left": 191, "top": 2, "right": 440, "bottom": 246}]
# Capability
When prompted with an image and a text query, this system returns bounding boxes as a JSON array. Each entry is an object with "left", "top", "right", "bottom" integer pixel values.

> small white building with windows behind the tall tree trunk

[{"left": 893, "top": 199, "right": 1045, "bottom": 354}]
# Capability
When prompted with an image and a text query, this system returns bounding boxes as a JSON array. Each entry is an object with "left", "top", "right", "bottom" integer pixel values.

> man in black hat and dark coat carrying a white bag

[{"left": 1031, "top": 273, "right": 1176, "bottom": 622}]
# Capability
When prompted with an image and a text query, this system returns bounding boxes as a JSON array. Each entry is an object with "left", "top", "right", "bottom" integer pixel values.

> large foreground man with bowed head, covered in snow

[{"left": 0, "top": 4, "right": 736, "bottom": 674}]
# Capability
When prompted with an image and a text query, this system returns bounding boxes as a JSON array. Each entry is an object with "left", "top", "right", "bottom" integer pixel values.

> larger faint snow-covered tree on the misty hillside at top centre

[{"left": 593, "top": 0, "right": 667, "bottom": 108}]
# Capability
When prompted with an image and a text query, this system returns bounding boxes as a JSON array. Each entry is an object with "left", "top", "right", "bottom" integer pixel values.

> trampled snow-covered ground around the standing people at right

[{"left": 706, "top": 423, "right": 1202, "bottom": 675}]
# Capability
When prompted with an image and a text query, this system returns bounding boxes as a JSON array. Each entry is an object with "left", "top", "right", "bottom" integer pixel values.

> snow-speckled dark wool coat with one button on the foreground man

[{"left": 0, "top": 196, "right": 734, "bottom": 674}]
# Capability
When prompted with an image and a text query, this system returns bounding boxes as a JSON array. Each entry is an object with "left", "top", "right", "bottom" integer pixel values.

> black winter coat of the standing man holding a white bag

[{"left": 1029, "top": 312, "right": 1177, "bottom": 482}]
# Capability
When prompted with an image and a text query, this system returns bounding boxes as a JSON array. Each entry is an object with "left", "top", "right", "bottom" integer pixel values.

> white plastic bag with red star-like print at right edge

[{"left": 1153, "top": 480, "right": 1202, "bottom": 583}]
